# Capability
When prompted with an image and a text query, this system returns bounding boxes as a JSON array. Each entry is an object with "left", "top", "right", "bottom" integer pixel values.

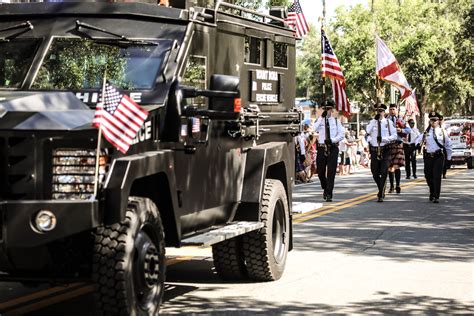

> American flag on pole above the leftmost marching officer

[{"left": 321, "top": 29, "right": 351, "bottom": 116}]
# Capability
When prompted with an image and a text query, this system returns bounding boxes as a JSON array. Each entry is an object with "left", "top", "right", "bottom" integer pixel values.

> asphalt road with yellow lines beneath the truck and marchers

[{"left": 0, "top": 164, "right": 474, "bottom": 315}]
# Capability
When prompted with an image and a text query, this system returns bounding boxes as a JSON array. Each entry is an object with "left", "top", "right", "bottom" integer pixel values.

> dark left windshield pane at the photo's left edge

[{"left": 0, "top": 39, "right": 41, "bottom": 88}]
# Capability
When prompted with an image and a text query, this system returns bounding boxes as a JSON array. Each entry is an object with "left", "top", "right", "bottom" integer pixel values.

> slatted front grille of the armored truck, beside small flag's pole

[{"left": 52, "top": 148, "right": 98, "bottom": 200}]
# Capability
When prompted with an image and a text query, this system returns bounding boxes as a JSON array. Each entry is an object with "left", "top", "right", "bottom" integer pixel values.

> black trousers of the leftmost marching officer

[{"left": 316, "top": 146, "right": 339, "bottom": 196}]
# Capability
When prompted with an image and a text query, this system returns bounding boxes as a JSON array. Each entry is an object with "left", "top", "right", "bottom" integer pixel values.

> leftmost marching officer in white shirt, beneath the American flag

[{"left": 314, "top": 100, "right": 344, "bottom": 202}]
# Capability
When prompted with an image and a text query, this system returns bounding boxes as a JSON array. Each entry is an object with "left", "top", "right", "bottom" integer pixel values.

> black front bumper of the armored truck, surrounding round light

[{"left": 0, "top": 200, "right": 100, "bottom": 248}]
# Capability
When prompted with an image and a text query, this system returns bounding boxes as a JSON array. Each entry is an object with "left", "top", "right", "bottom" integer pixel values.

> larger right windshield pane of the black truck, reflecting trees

[{"left": 32, "top": 38, "right": 171, "bottom": 90}]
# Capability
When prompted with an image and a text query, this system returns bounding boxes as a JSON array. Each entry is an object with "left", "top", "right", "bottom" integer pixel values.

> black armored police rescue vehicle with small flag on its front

[{"left": 0, "top": 0, "right": 302, "bottom": 315}]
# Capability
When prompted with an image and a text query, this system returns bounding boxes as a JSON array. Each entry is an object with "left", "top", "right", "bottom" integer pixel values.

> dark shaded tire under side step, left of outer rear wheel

[{"left": 212, "top": 237, "right": 248, "bottom": 281}]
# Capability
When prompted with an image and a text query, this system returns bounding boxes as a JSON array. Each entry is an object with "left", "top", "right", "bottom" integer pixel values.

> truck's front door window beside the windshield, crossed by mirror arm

[{"left": 183, "top": 56, "right": 207, "bottom": 106}]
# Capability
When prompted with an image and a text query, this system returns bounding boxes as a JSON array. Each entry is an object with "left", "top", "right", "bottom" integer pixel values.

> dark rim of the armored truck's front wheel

[{"left": 132, "top": 228, "right": 161, "bottom": 310}]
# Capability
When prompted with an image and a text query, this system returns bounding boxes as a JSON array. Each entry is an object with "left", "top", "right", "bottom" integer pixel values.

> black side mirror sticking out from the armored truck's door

[{"left": 209, "top": 75, "right": 240, "bottom": 112}]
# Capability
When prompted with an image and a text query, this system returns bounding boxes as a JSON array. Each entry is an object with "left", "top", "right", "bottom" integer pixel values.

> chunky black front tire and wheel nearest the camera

[{"left": 92, "top": 197, "right": 166, "bottom": 315}]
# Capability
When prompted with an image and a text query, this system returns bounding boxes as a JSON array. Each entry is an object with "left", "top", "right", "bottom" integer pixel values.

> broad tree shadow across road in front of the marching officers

[{"left": 294, "top": 170, "right": 474, "bottom": 262}]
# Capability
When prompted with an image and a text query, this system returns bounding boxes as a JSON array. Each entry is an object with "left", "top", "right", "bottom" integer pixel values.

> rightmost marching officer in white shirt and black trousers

[{"left": 416, "top": 112, "right": 453, "bottom": 203}]
